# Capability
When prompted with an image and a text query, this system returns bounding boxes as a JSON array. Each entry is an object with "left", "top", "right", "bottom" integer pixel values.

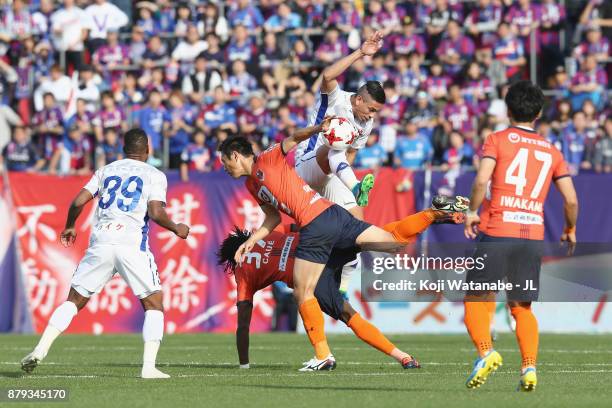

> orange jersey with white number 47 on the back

[{"left": 479, "top": 127, "right": 569, "bottom": 240}]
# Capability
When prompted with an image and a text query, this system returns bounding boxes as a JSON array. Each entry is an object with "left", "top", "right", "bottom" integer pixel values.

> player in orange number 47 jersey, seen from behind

[{"left": 464, "top": 81, "right": 578, "bottom": 391}]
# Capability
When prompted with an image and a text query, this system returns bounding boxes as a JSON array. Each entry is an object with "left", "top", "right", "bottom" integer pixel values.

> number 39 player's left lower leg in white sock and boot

[{"left": 21, "top": 288, "right": 89, "bottom": 373}]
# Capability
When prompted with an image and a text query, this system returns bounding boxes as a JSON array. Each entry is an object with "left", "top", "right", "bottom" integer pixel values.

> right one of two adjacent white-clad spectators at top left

[{"left": 85, "top": 0, "right": 129, "bottom": 54}]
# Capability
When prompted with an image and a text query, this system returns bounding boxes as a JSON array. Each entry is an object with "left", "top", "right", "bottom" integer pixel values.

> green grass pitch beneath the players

[{"left": 0, "top": 334, "right": 612, "bottom": 408}]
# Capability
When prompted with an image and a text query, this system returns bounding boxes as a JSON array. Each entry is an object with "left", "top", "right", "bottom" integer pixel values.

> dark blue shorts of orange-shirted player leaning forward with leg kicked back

[{"left": 295, "top": 204, "right": 371, "bottom": 264}]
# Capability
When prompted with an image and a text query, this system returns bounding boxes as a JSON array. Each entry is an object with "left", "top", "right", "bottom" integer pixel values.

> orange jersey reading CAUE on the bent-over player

[{"left": 235, "top": 231, "right": 299, "bottom": 302}]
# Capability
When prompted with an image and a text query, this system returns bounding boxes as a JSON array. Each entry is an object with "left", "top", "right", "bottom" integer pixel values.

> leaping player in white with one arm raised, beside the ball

[{"left": 295, "top": 31, "right": 386, "bottom": 293}]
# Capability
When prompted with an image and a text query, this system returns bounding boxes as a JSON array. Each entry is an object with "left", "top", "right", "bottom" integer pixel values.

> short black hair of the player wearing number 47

[{"left": 505, "top": 81, "right": 544, "bottom": 123}]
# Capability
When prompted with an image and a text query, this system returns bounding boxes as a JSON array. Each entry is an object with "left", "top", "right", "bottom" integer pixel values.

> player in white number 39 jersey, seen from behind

[{"left": 21, "top": 129, "right": 189, "bottom": 378}]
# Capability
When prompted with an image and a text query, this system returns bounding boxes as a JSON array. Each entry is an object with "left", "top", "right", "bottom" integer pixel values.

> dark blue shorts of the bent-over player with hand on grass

[{"left": 315, "top": 247, "right": 359, "bottom": 320}]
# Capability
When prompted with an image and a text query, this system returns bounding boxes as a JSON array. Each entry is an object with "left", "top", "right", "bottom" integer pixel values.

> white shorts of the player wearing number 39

[{"left": 71, "top": 244, "right": 161, "bottom": 299}]
